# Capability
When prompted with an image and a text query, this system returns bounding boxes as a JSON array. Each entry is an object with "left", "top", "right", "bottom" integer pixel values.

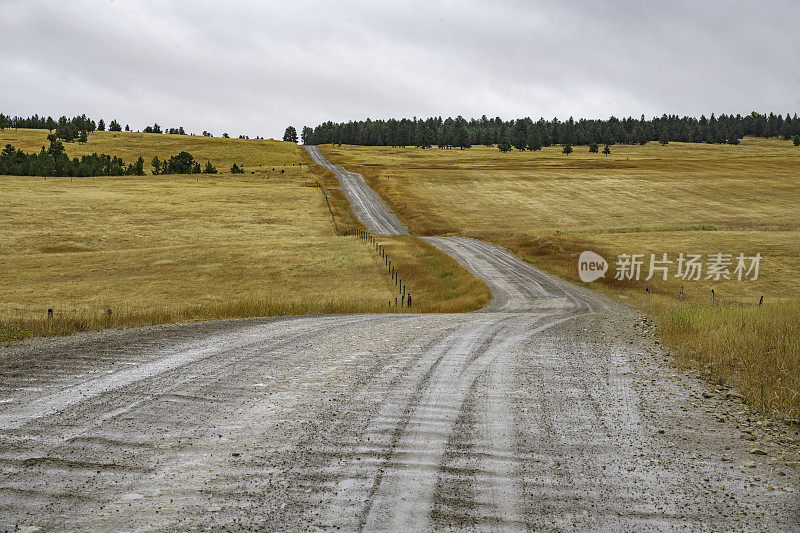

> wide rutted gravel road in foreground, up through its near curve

[{"left": 0, "top": 149, "right": 800, "bottom": 531}]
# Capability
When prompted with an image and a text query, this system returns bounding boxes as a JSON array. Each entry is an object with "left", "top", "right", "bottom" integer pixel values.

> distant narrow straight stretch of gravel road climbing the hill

[{"left": 303, "top": 144, "right": 408, "bottom": 235}]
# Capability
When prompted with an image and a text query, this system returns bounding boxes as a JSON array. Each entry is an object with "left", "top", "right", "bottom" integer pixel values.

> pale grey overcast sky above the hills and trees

[{"left": 0, "top": 0, "right": 800, "bottom": 138}]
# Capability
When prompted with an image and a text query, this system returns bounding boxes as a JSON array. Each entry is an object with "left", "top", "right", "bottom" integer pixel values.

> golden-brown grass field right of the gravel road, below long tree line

[{"left": 321, "top": 138, "right": 800, "bottom": 418}]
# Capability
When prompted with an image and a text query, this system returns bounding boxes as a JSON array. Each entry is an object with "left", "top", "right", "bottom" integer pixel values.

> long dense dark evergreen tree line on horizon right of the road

[{"left": 301, "top": 112, "right": 800, "bottom": 150}]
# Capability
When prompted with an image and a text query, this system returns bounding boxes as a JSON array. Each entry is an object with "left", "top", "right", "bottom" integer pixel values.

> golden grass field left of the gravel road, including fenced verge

[{"left": 0, "top": 130, "right": 488, "bottom": 342}]
